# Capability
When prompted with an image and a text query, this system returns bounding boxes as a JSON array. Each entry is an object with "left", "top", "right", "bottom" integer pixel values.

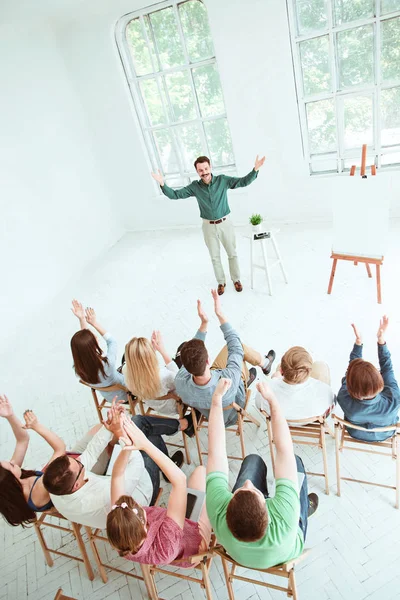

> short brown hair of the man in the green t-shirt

[{"left": 226, "top": 490, "right": 268, "bottom": 542}]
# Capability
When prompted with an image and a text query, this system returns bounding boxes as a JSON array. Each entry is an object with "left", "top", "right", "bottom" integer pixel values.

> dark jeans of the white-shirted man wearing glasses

[{"left": 132, "top": 415, "right": 179, "bottom": 506}]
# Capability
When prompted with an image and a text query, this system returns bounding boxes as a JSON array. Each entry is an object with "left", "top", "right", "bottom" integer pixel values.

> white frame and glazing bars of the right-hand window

[{"left": 286, "top": 0, "right": 400, "bottom": 176}]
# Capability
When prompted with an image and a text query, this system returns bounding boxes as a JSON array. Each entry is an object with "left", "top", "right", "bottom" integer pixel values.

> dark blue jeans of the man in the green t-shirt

[{"left": 232, "top": 454, "right": 308, "bottom": 539}]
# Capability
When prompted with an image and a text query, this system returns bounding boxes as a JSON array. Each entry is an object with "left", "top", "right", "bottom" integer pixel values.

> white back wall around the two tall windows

[{"left": 52, "top": 0, "right": 400, "bottom": 230}]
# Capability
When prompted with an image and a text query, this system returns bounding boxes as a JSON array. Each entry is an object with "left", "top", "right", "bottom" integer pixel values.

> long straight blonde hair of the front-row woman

[{"left": 125, "top": 338, "right": 161, "bottom": 400}]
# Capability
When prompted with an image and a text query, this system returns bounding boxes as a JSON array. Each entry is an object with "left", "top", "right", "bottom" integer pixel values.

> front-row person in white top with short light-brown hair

[{"left": 256, "top": 346, "right": 335, "bottom": 420}]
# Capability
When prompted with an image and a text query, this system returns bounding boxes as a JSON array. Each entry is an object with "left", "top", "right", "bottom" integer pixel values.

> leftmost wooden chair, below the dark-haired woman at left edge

[{"left": 34, "top": 508, "right": 94, "bottom": 581}]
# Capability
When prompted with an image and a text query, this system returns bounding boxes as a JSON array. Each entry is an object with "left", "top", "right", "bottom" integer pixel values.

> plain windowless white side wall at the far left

[{"left": 0, "top": 20, "right": 123, "bottom": 347}]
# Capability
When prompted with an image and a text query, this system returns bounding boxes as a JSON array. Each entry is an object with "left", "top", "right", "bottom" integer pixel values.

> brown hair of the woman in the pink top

[{"left": 107, "top": 495, "right": 147, "bottom": 556}]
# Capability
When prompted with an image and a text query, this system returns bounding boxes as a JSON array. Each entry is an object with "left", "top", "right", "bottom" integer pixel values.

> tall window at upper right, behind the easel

[{"left": 287, "top": 0, "right": 400, "bottom": 174}]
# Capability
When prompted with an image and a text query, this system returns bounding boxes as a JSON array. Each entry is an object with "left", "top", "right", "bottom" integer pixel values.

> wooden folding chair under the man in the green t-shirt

[{"left": 213, "top": 546, "right": 309, "bottom": 600}]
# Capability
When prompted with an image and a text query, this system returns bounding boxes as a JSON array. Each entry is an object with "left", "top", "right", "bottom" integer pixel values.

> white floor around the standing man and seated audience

[{"left": 0, "top": 223, "right": 400, "bottom": 600}]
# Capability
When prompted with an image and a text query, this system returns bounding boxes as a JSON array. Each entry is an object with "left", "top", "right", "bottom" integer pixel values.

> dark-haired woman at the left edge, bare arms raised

[{"left": 0, "top": 395, "right": 65, "bottom": 527}]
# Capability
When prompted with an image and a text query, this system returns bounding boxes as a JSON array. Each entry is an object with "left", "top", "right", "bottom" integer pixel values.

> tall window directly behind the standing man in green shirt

[{"left": 116, "top": 0, "right": 235, "bottom": 187}]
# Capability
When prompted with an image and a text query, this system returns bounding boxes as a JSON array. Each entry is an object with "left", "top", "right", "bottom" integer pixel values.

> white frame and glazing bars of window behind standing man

[{"left": 115, "top": 0, "right": 236, "bottom": 188}]
